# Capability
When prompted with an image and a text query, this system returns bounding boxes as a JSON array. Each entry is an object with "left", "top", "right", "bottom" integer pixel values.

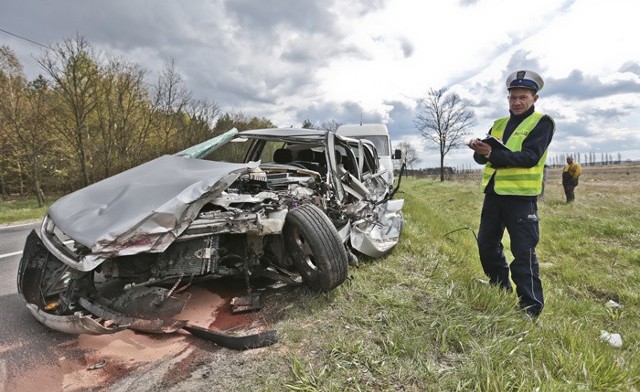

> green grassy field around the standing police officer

[{"left": 1, "top": 166, "right": 640, "bottom": 391}]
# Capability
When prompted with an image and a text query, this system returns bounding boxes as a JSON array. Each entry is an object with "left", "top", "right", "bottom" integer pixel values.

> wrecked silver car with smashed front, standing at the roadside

[{"left": 18, "top": 128, "right": 404, "bottom": 348}]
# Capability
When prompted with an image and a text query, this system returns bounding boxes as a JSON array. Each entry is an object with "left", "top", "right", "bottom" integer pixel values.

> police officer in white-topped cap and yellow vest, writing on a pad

[{"left": 468, "top": 70, "right": 555, "bottom": 320}]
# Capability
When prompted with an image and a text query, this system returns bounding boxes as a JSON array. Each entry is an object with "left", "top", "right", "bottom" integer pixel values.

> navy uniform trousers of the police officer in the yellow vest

[{"left": 478, "top": 193, "right": 544, "bottom": 317}]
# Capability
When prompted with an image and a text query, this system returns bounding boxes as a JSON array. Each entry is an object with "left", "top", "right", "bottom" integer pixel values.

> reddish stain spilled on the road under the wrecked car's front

[{"left": 0, "top": 280, "right": 284, "bottom": 392}]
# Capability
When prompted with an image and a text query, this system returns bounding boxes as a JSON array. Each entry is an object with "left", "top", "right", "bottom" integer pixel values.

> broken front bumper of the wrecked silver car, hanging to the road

[{"left": 18, "top": 231, "right": 278, "bottom": 350}]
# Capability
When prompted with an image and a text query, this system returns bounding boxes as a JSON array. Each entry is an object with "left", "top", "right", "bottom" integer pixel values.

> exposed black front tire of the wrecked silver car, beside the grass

[{"left": 283, "top": 204, "right": 349, "bottom": 293}]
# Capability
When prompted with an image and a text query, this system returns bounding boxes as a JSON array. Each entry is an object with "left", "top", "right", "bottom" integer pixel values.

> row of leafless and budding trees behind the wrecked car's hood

[{"left": 0, "top": 36, "right": 274, "bottom": 205}]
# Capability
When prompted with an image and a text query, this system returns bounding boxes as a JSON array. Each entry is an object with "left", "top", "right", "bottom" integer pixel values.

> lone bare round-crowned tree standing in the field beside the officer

[{"left": 415, "top": 88, "right": 475, "bottom": 181}]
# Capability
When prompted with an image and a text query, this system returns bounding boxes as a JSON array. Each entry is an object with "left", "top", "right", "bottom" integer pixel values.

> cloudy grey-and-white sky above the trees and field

[{"left": 0, "top": 0, "right": 640, "bottom": 167}]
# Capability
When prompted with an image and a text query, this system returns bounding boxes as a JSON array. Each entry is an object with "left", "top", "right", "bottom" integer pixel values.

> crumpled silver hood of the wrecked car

[{"left": 48, "top": 155, "right": 259, "bottom": 256}]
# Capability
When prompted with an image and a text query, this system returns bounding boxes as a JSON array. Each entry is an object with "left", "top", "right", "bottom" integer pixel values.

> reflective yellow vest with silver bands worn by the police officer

[{"left": 482, "top": 112, "right": 555, "bottom": 196}]
